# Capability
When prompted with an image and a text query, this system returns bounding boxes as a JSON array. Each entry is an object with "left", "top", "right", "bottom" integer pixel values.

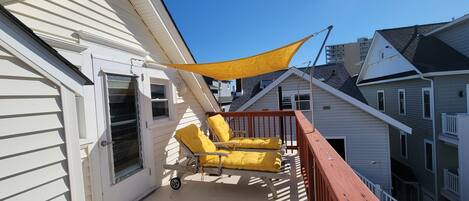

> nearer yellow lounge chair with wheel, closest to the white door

[{"left": 164, "top": 124, "right": 290, "bottom": 197}]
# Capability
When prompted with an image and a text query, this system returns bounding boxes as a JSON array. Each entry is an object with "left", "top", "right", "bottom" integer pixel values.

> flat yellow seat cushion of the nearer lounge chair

[{"left": 202, "top": 150, "right": 282, "bottom": 172}]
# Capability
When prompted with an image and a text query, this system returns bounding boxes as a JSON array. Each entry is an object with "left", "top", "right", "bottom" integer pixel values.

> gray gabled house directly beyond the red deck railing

[{"left": 232, "top": 64, "right": 411, "bottom": 191}]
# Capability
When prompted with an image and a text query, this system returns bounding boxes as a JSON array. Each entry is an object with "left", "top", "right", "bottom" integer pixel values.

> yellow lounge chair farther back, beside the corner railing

[{"left": 207, "top": 114, "right": 284, "bottom": 150}]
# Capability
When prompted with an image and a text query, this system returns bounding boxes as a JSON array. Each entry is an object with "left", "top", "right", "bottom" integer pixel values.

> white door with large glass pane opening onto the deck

[{"left": 93, "top": 59, "right": 156, "bottom": 201}]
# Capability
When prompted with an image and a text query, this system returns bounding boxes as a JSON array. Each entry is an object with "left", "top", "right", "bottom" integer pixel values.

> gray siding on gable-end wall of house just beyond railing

[{"left": 246, "top": 75, "right": 391, "bottom": 190}]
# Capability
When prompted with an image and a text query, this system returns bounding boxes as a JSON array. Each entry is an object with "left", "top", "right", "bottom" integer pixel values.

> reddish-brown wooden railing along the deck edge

[{"left": 209, "top": 111, "right": 378, "bottom": 201}]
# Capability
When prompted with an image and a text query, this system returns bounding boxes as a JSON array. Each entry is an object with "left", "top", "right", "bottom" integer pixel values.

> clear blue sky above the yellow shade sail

[{"left": 165, "top": 0, "right": 469, "bottom": 66}]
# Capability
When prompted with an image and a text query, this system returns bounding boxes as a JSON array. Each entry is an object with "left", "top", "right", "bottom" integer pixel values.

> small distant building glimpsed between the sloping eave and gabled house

[{"left": 204, "top": 77, "right": 233, "bottom": 112}]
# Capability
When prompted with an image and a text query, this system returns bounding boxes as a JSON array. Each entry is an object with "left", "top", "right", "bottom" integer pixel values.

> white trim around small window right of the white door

[{"left": 148, "top": 77, "right": 175, "bottom": 124}]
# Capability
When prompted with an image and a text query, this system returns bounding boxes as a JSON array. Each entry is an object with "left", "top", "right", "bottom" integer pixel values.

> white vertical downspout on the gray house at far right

[{"left": 417, "top": 70, "right": 439, "bottom": 201}]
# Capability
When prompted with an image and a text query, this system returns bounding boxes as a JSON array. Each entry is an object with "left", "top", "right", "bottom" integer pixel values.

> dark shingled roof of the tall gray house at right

[{"left": 378, "top": 22, "right": 469, "bottom": 73}]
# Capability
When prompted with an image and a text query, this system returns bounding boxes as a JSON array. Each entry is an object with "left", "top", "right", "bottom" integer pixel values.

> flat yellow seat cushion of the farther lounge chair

[{"left": 229, "top": 137, "right": 282, "bottom": 149}]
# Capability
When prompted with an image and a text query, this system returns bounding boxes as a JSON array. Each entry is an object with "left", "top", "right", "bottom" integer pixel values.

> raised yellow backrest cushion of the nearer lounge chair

[{"left": 176, "top": 124, "right": 217, "bottom": 153}]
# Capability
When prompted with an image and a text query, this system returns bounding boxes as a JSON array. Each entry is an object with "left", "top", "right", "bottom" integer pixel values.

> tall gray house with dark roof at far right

[{"left": 357, "top": 16, "right": 469, "bottom": 201}]
